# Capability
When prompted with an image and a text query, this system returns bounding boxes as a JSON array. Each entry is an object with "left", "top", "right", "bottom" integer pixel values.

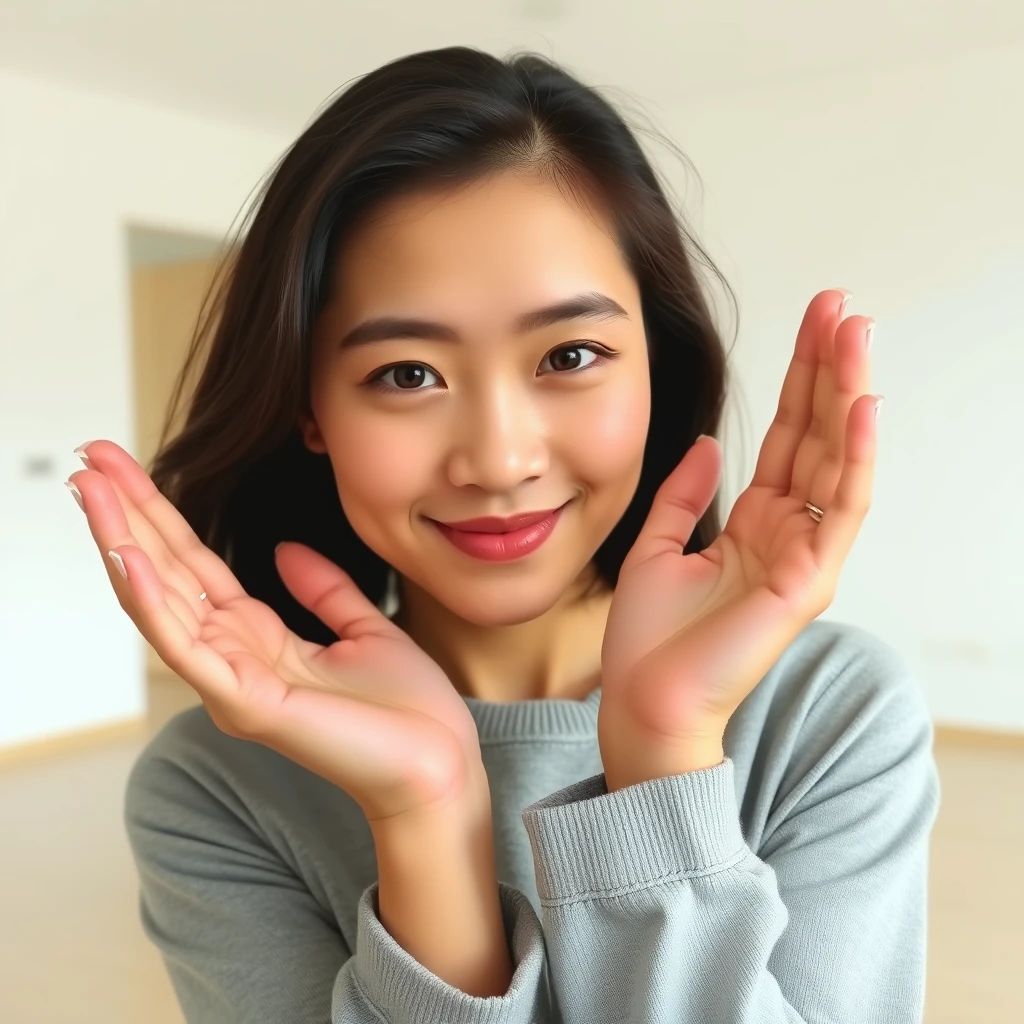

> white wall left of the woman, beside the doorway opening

[{"left": 0, "top": 70, "right": 289, "bottom": 745}]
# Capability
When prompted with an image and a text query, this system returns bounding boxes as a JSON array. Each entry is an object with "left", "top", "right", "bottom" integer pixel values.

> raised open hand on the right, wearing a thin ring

[{"left": 598, "top": 290, "right": 878, "bottom": 788}]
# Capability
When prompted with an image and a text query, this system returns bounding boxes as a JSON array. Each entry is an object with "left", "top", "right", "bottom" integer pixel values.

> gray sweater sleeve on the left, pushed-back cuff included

[{"left": 125, "top": 755, "right": 548, "bottom": 1024}]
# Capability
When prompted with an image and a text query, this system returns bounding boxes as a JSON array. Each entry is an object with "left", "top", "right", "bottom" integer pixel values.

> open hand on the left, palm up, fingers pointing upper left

[{"left": 69, "top": 440, "right": 479, "bottom": 822}]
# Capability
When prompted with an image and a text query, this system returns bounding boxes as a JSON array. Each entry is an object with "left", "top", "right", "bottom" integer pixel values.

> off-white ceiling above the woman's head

[{"left": 0, "top": 0, "right": 1024, "bottom": 133}]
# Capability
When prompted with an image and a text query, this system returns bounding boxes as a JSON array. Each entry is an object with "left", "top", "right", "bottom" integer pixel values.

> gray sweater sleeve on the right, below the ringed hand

[{"left": 523, "top": 647, "right": 939, "bottom": 1024}]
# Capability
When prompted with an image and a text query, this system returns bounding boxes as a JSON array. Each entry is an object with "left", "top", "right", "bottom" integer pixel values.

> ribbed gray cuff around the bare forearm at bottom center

[{"left": 353, "top": 882, "right": 548, "bottom": 1024}]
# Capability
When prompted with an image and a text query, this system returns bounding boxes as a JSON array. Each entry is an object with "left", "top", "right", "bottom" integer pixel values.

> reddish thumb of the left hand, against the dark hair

[{"left": 274, "top": 541, "right": 394, "bottom": 640}]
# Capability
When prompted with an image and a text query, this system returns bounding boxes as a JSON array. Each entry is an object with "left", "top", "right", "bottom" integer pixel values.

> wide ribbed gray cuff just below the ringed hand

[{"left": 522, "top": 758, "right": 750, "bottom": 902}]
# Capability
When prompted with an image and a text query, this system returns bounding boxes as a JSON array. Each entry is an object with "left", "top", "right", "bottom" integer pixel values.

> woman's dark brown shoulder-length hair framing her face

[{"left": 150, "top": 46, "right": 735, "bottom": 643}]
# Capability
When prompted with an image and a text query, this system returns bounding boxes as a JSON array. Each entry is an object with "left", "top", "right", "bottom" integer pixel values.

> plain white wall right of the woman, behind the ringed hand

[{"left": 657, "top": 41, "right": 1024, "bottom": 730}]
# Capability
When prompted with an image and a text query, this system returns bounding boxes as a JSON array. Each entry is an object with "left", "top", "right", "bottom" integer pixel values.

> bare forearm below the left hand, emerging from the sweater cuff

[{"left": 372, "top": 766, "right": 512, "bottom": 996}]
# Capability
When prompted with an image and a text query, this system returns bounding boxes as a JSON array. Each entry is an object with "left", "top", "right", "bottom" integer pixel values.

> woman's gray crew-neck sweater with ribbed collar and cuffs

[{"left": 125, "top": 620, "right": 939, "bottom": 1024}]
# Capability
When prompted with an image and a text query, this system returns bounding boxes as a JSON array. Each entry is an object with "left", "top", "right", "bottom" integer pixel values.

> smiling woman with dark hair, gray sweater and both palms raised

[{"left": 70, "top": 47, "right": 937, "bottom": 1024}]
